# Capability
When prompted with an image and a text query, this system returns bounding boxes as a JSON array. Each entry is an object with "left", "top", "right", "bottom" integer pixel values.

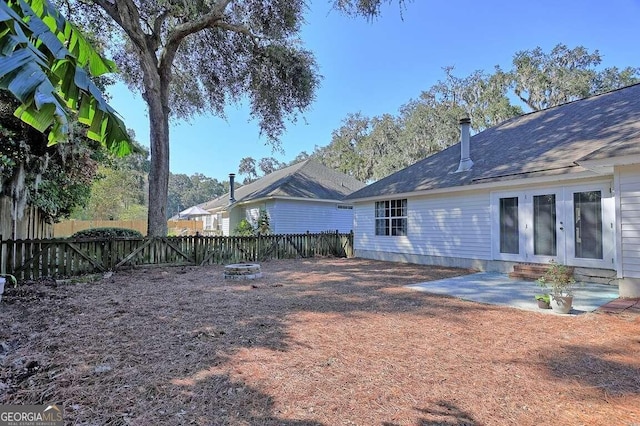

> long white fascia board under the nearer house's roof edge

[{"left": 347, "top": 171, "right": 602, "bottom": 204}]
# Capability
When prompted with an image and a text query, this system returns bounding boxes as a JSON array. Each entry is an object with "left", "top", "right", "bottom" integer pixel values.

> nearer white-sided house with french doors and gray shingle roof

[{"left": 345, "top": 85, "right": 640, "bottom": 297}]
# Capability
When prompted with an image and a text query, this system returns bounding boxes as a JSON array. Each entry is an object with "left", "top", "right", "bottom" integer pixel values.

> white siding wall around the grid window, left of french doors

[{"left": 354, "top": 192, "right": 491, "bottom": 260}]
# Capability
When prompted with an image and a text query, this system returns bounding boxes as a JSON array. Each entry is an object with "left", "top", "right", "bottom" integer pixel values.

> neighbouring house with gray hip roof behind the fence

[{"left": 200, "top": 159, "right": 365, "bottom": 235}]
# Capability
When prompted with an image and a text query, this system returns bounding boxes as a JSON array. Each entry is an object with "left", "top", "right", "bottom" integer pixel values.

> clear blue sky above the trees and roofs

[{"left": 105, "top": 0, "right": 640, "bottom": 180}]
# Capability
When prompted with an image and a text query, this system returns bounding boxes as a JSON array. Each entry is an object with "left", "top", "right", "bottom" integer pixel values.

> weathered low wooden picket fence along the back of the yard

[{"left": 0, "top": 233, "right": 353, "bottom": 280}]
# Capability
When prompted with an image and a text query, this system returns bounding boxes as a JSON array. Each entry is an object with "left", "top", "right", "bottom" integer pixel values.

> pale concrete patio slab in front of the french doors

[{"left": 407, "top": 272, "right": 618, "bottom": 314}]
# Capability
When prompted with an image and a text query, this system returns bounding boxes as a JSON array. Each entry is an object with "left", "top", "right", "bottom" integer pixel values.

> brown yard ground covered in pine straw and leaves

[{"left": 0, "top": 259, "right": 640, "bottom": 426}]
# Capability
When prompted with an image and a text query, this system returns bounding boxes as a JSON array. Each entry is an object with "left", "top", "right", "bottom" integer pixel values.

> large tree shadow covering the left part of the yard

[{"left": 0, "top": 260, "right": 528, "bottom": 426}]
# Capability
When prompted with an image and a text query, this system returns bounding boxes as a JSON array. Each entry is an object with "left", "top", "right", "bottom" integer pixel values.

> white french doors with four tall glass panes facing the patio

[{"left": 492, "top": 185, "right": 614, "bottom": 268}]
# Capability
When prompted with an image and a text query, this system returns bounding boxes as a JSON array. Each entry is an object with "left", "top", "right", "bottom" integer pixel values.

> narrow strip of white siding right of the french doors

[{"left": 619, "top": 166, "right": 640, "bottom": 278}]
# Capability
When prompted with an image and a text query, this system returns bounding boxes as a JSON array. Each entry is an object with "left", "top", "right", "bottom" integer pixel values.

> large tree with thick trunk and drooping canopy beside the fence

[{"left": 56, "top": 0, "right": 403, "bottom": 236}]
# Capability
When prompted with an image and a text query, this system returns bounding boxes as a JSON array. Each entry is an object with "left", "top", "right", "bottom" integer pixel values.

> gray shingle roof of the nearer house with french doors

[{"left": 347, "top": 84, "right": 640, "bottom": 200}]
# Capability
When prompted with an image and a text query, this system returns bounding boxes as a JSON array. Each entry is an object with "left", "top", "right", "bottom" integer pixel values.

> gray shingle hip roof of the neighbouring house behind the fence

[{"left": 200, "top": 159, "right": 365, "bottom": 210}]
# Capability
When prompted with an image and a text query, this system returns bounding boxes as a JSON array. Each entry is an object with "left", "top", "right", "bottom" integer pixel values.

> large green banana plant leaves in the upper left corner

[{"left": 0, "top": 0, "right": 133, "bottom": 155}]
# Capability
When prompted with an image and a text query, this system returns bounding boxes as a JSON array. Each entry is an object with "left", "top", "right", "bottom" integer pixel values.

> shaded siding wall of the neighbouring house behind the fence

[{"left": 267, "top": 200, "right": 353, "bottom": 234}]
